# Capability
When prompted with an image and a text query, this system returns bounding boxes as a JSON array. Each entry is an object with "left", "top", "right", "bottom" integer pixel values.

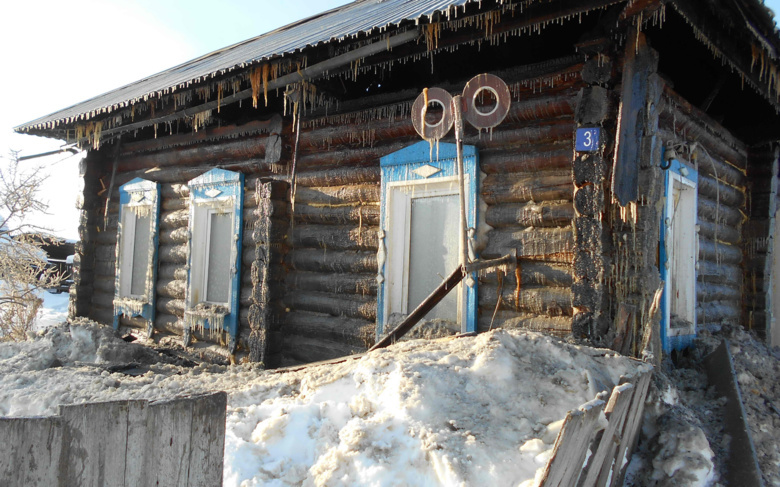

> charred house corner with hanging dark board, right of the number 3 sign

[{"left": 604, "top": 37, "right": 663, "bottom": 359}]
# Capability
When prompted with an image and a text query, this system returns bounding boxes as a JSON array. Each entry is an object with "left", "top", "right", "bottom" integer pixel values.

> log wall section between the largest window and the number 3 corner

[{"left": 474, "top": 76, "right": 583, "bottom": 335}]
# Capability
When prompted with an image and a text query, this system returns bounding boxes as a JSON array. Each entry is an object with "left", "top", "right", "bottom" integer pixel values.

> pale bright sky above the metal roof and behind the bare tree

[{"left": 0, "top": 0, "right": 780, "bottom": 239}]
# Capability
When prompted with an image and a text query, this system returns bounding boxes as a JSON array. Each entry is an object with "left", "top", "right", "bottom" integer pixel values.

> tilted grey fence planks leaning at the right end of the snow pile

[{"left": 540, "top": 370, "right": 652, "bottom": 487}]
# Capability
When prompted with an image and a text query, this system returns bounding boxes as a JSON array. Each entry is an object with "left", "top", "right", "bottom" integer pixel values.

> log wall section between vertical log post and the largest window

[{"left": 283, "top": 147, "right": 384, "bottom": 362}]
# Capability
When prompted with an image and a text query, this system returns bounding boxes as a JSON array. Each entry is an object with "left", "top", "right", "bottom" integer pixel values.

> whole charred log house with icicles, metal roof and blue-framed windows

[{"left": 16, "top": 0, "right": 780, "bottom": 367}]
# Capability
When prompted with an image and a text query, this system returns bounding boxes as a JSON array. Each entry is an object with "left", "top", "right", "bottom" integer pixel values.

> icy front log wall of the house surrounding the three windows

[{"left": 75, "top": 56, "right": 584, "bottom": 363}]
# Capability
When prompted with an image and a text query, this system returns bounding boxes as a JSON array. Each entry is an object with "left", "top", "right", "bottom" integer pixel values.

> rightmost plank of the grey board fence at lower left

[{"left": 187, "top": 392, "right": 227, "bottom": 487}]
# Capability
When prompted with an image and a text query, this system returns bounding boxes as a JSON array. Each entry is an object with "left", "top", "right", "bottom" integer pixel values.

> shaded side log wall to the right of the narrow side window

[{"left": 659, "top": 87, "right": 748, "bottom": 332}]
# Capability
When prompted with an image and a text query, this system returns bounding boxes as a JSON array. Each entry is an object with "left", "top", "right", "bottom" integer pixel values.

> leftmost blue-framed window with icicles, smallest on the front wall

[{"left": 114, "top": 178, "right": 160, "bottom": 335}]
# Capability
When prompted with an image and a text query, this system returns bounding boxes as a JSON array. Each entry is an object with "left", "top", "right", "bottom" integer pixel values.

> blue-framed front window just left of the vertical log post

[{"left": 184, "top": 169, "right": 244, "bottom": 352}]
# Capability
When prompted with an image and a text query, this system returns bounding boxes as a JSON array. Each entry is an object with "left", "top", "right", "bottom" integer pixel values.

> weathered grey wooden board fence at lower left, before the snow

[{"left": 0, "top": 392, "right": 227, "bottom": 487}]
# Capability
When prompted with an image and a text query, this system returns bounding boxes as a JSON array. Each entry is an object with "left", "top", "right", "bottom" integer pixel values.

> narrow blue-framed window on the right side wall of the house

[{"left": 661, "top": 159, "right": 698, "bottom": 352}]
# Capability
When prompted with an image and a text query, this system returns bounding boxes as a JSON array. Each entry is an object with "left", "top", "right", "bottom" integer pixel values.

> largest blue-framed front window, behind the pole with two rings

[{"left": 377, "top": 142, "right": 477, "bottom": 336}]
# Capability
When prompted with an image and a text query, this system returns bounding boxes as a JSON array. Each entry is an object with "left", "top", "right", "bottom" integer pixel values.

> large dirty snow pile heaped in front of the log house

[{"left": 0, "top": 326, "right": 647, "bottom": 486}]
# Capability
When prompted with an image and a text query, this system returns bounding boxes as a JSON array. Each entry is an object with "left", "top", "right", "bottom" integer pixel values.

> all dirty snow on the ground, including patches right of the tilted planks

[{"left": 0, "top": 314, "right": 780, "bottom": 487}]
